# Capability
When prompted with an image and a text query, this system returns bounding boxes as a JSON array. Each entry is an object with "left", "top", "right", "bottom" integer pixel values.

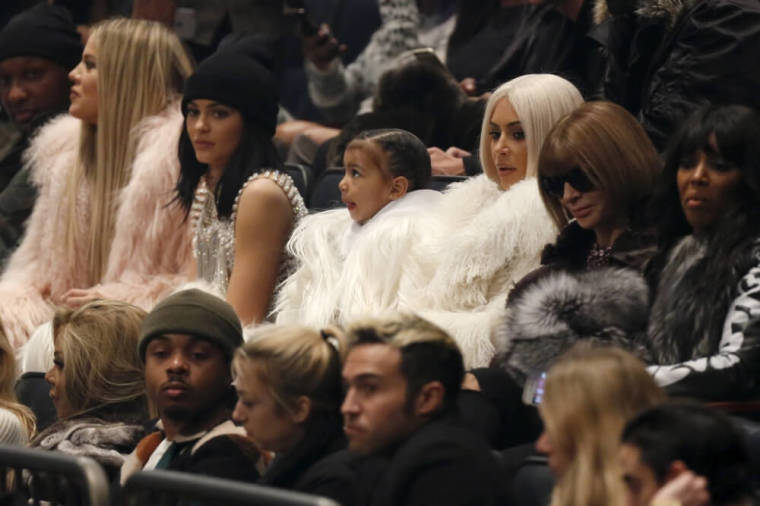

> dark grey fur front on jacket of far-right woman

[{"left": 648, "top": 235, "right": 760, "bottom": 364}]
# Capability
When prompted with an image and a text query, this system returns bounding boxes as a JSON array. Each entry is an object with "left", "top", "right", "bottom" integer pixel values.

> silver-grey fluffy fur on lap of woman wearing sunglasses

[{"left": 493, "top": 268, "right": 649, "bottom": 384}]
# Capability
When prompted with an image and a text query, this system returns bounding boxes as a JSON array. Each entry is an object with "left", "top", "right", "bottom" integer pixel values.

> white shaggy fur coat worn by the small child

[{"left": 274, "top": 190, "right": 440, "bottom": 328}]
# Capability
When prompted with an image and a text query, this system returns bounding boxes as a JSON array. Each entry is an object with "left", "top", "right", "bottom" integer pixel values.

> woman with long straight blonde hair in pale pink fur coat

[{"left": 0, "top": 19, "right": 192, "bottom": 348}]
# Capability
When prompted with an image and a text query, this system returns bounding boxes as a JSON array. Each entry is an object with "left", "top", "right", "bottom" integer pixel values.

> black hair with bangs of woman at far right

[{"left": 651, "top": 105, "right": 760, "bottom": 250}]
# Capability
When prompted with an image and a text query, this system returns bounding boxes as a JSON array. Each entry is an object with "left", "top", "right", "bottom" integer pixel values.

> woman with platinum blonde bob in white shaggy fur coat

[{"left": 401, "top": 74, "right": 583, "bottom": 368}]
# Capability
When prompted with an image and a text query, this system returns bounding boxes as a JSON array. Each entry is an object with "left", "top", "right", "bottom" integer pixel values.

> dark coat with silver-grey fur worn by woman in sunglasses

[{"left": 493, "top": 222, "right": 656, "bottom": 386}]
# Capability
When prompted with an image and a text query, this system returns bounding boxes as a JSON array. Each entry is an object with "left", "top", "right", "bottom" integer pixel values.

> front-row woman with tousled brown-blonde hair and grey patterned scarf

[{"left": 31, "top": 300, "right": 149, "bottom": 478}]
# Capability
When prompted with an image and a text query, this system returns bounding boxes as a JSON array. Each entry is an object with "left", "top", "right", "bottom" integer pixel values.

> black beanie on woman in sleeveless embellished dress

[{"left": 182, "top": 49, "right": 280, "bottom": 136}]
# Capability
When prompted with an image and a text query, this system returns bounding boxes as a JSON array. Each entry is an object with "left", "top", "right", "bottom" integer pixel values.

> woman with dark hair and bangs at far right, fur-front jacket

[{"left": 646, "top": 105, "right": 760, "bottom": 401}]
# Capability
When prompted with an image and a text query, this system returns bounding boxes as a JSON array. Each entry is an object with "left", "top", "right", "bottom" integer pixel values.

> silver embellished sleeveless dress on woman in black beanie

[{"left": 191, "top": 170, "right": 306, "bottom": 294}]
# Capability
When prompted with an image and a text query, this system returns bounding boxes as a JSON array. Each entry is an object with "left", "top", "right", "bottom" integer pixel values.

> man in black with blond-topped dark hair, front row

[{"left": 342, "top": 315, "right": 505, "bottom": 506}]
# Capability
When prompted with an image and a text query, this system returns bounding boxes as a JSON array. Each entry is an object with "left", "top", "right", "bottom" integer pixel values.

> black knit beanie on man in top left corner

[{"left": 0, "top": 3, "right": 82, "bottom": 70}]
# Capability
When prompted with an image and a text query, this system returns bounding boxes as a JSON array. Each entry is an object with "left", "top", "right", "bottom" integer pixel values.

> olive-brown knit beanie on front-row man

[{"left": 137, "top": 288, "right": 243, "bottom": 362}]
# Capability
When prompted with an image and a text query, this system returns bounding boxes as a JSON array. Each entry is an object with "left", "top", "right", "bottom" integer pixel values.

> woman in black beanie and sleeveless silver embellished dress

[{"left": 176, "top": 42, "right": 306, "bottom": 325}]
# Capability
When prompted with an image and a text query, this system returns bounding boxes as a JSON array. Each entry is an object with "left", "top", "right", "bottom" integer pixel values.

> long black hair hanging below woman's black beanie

[{"left": 174, "top": 119, "right": 283, "bottom": 218}]
